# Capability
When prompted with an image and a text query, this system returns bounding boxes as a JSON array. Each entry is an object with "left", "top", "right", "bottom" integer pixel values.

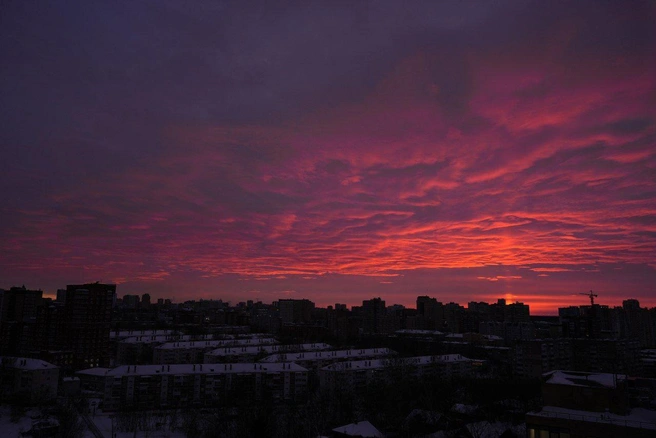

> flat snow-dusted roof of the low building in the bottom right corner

[{"left": 527, "top": 406, "right": 656, "bottom": 430}]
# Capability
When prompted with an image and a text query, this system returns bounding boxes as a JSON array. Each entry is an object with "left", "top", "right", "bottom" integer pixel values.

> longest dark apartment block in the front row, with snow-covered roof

[{"left": 76, "top": 363, "right": 308, "bottom": 411}]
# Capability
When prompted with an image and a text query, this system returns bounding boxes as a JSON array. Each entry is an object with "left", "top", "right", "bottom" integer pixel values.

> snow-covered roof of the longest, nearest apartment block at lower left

[{"left": 78, "top": 362, "right": 307, "bottom": 377}]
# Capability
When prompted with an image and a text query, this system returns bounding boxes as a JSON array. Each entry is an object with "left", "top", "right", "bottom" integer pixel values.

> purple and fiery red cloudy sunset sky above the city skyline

[{"left": 0, "top": 0, "right": 656, "bottom": 314}]
